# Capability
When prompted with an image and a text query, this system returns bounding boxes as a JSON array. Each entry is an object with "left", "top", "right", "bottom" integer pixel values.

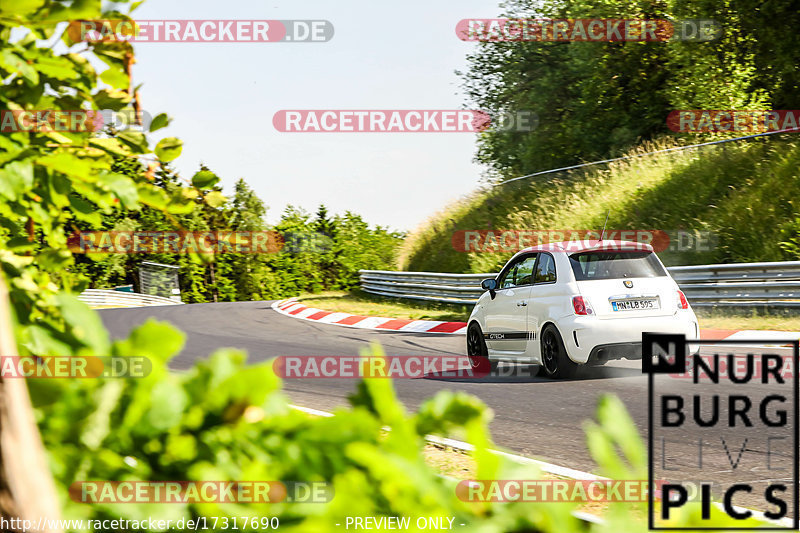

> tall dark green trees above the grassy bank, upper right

[{"left": 462, "top": 0, "right": 800, "bottom": 179}]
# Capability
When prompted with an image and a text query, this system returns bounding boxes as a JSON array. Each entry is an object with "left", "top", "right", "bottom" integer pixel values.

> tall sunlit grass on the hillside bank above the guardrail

[{"left": 400, "top": 135, "right": 800, "bottom": 272}]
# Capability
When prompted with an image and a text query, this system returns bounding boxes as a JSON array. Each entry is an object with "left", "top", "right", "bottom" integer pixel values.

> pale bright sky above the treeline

[{"left": 123, "top": 0, "right": 499, "bottom": 231}]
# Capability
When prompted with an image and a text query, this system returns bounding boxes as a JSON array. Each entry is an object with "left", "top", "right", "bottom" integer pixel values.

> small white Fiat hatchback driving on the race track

[{"left": 467, "top": 240, "right": 700, "bottom": 378}]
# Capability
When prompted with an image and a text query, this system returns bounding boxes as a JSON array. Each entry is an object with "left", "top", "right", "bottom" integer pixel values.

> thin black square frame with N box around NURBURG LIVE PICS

[{"left": 642, "top": 333, "right": 800, "bottom": 531}]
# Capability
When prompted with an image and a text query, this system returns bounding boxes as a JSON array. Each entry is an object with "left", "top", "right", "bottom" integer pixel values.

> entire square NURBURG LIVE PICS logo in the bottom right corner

[{"left": 642, "top": 333, "right": 800, "bottom": 531}]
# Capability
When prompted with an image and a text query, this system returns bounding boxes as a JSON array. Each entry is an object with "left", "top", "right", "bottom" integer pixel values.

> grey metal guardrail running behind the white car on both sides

[{"left": 359, "top": 261, "right": 800, "bottom": 307}]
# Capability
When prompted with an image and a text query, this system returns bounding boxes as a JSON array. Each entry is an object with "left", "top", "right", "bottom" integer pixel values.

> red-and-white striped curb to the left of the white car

[{"left": 272, "top": 298, "right": 467, "bottom": 335}]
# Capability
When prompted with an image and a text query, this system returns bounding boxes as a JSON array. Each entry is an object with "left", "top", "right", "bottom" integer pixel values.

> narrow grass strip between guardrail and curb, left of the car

[{"left": 298, "top": 290, "right": 472, "bottom": 322}]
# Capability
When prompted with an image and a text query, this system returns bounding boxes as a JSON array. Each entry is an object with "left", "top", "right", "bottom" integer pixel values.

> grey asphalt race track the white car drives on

[{"left": 100, "top": 302, "right": 793, "bottom": 509}]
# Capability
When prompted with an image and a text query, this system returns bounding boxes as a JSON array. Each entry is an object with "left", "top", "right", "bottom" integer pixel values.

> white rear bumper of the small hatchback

[{"left": 559, "top": 310, "right": 700, "bottom": 363}]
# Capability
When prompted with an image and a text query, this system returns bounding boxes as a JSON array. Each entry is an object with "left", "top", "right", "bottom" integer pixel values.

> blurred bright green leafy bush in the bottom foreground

[{"left": 32, "top": 330, "right": 764, "bottom": 533}]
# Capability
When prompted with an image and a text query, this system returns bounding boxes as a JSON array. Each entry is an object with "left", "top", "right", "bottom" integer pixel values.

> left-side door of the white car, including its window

[{"left": 484, "top": 253, "right": 537, "bottom": 356}]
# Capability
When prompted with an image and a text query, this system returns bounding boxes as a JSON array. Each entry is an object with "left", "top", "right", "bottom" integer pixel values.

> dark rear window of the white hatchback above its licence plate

[{"left": 569, "top": 251, "right": 667, "bottom": 281}]
